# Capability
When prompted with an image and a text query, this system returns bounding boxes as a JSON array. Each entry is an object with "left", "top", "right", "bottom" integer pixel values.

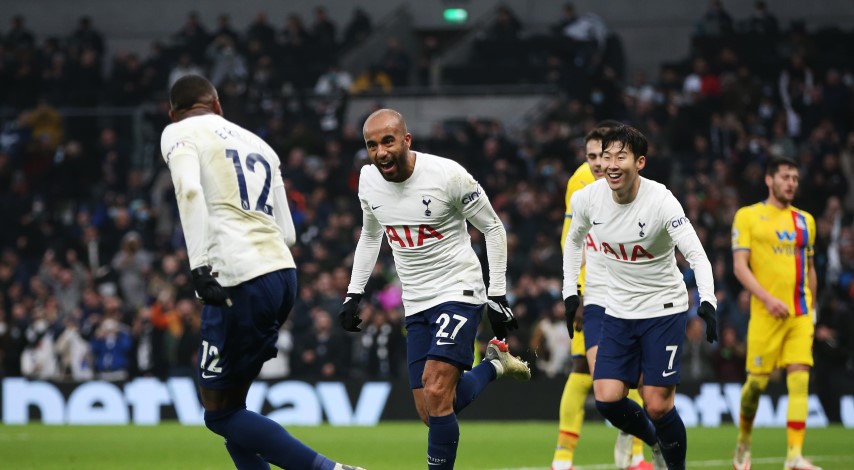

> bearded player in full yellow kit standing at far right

[{"left": 732, "top": 158, "right": 821, "bottom": 470}]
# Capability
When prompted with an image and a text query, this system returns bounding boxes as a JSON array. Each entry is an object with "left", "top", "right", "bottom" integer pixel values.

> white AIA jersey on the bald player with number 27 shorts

[{"left": 359, "top": 152, "right": 489, "bottom": 315}]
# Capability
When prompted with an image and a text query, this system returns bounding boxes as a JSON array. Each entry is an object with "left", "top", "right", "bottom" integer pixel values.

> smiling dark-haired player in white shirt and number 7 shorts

[{"left": 563, "top": 126, "right": 717, "bottom": 470}]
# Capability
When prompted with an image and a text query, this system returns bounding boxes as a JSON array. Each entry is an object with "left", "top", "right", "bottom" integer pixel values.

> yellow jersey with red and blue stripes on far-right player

[{"left": 732, "top": 202, "right": 815, "bottom": 316}]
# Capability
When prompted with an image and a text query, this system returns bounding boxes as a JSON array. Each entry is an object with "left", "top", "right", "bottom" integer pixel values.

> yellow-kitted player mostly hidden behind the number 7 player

[{"left": 551, "top": 121, "right": 652, "bottom": 470}]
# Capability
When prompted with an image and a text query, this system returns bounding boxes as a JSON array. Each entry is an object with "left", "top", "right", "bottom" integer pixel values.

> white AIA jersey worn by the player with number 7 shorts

[{"left": 565, "top": 177, "right": 716, "bottom": 319}]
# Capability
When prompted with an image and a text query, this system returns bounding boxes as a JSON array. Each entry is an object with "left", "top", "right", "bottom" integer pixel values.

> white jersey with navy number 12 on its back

[{"left": 160, "top": 114, "right": 295, "bottom": 286}]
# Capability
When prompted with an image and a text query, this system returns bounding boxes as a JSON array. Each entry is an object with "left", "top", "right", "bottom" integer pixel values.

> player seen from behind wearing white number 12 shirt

[{"left": 160, "top": 75, "right": 359, "bottom": 470}]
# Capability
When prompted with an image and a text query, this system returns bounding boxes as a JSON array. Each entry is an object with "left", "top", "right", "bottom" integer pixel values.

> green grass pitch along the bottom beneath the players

[{"left": 0, "top": 420, "right": 854, "bottom": 470}]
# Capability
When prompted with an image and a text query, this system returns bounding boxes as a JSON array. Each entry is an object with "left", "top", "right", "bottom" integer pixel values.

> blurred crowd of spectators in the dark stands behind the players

[{"left": 0, "top": 1, "right": 854, "bottom": 419}]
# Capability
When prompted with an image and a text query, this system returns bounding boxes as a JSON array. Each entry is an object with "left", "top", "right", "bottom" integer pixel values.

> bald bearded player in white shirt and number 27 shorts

[{"left": 339, "top": 109, "right": 531, "bottom": 470}]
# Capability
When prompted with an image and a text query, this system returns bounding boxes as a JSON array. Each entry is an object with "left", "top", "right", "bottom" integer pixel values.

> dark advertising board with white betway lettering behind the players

[{"left": 0, "top": 377, "right": 854, "bottom": 428}]
